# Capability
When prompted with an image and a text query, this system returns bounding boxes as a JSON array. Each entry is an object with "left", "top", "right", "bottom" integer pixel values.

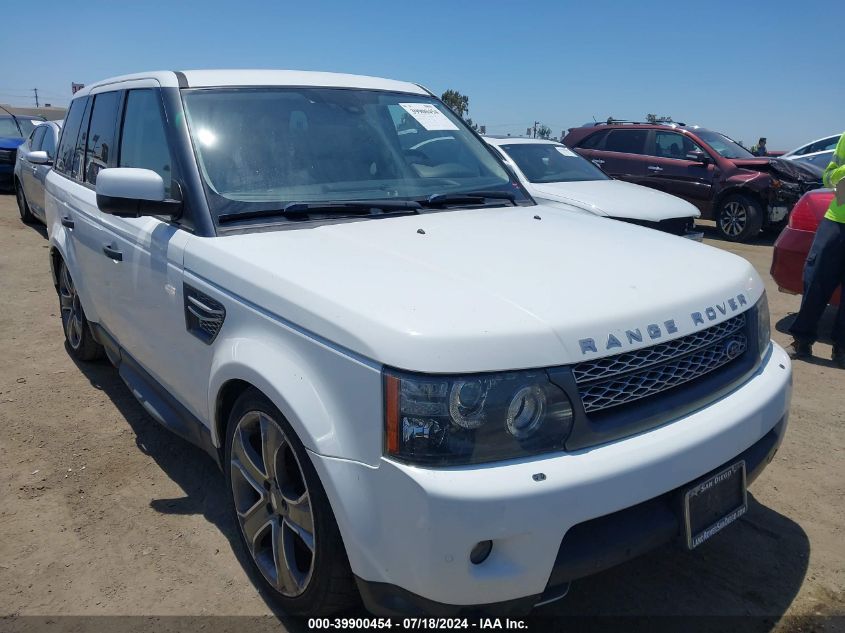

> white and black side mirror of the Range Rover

[{"left": 96, "top": 167, "right": 182, "bottom": 218}]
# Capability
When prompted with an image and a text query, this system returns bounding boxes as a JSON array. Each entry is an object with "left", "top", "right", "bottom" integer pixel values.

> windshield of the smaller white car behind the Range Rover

[{"left": 502, "top": 143, "right": 610, "bottom": 183}]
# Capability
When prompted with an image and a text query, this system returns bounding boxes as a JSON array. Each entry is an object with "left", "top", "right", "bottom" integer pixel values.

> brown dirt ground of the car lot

[{"left": 0, "top": 195, "right": 845, "bottom": 631}]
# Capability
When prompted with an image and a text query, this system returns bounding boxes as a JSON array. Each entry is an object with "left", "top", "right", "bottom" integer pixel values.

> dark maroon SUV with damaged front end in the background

[{"left": 563, "top": 121, "right": 821, "bottom": 242}]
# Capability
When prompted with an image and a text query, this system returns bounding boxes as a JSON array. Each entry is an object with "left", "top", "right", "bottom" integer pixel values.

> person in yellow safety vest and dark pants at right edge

[{"left": 789, "top": 134, "right": 845, "bottom": 369}]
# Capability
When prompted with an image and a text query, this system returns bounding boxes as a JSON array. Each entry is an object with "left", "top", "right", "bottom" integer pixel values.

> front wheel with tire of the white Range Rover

[{"left": 224, "top": 389, "right": 359, "bottom": 617}]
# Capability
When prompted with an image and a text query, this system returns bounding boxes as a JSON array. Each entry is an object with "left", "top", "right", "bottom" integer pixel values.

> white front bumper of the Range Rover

[{"left": 312, "top": 344, "right": 791, "bottom": 614}]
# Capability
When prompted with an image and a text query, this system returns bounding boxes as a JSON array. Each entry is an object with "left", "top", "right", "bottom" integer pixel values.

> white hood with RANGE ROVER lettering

[{"left": 184, "top": 205, "right": 763, "bottom": 372}]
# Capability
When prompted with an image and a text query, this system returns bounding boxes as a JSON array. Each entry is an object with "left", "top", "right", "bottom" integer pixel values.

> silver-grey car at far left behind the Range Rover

[{"left": 14, "top": 121, "right": 62, "bottom": 223}]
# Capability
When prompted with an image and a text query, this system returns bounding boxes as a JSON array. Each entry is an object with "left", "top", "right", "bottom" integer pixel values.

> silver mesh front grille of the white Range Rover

[{"left": 573, "top": 314, "right": 748, "bottom": 413}]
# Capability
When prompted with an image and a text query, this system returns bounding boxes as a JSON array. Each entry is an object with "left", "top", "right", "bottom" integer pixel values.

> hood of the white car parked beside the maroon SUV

[{"left": 529, "top": 180, "right": 701, "bottom": 222}]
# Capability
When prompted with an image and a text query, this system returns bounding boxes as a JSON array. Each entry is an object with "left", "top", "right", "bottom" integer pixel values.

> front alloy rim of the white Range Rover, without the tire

[{"left": 230, "top": 411, "right": 315, "bottom": 597}]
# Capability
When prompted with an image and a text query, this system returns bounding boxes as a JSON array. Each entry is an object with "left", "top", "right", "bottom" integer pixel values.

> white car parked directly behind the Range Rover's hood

[{"left": 484, "top": 136, "right": 703, "bottom": 241}]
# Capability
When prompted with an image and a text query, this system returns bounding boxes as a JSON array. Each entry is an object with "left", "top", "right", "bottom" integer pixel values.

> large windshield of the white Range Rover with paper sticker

[{"left": 183, "top": 87, "right": 528, "bottom": 216}]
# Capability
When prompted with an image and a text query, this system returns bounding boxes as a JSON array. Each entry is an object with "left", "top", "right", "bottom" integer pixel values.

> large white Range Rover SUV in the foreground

[{"left": 47, "top": 70, "right": 791, "bottom": 615}]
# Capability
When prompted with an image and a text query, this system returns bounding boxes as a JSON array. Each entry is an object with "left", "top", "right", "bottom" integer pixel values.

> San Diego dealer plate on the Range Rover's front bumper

[{"left": 684, "top": 461, "right": 748, "bottom": 549}]
